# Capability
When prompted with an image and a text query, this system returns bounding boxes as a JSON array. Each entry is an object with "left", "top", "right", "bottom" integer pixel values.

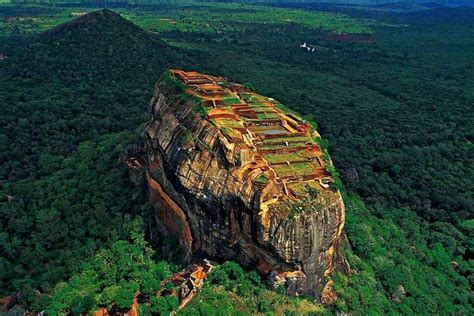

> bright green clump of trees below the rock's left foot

[{"left": 46, "top": 217, "right": 173, "bottom": 315}]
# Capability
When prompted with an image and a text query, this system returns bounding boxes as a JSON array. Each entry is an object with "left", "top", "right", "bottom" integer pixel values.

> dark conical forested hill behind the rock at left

[{"left": 0, "top": 10, "right": 179, "bottom": 180}]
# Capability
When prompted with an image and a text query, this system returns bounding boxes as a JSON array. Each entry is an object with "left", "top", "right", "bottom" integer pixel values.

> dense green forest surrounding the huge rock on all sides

[{"left": 0, "top": 4, "right": 474, "bottom": 314}]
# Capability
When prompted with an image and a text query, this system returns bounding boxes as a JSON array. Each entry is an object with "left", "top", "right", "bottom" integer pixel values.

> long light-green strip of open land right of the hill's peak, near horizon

[{"left": 119, "top": 2, "right": 372, "bottom": 33}]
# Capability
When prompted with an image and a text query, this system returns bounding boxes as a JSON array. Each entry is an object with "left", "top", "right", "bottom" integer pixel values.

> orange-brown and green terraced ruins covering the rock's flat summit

[{"left": 171, "top": 69, "right": 332, "bottom": 197}]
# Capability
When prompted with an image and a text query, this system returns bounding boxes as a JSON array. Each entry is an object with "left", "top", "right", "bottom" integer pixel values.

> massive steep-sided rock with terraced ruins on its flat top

[{"left": 144, "top": 70, "right": 348, "bottom": 302}]
